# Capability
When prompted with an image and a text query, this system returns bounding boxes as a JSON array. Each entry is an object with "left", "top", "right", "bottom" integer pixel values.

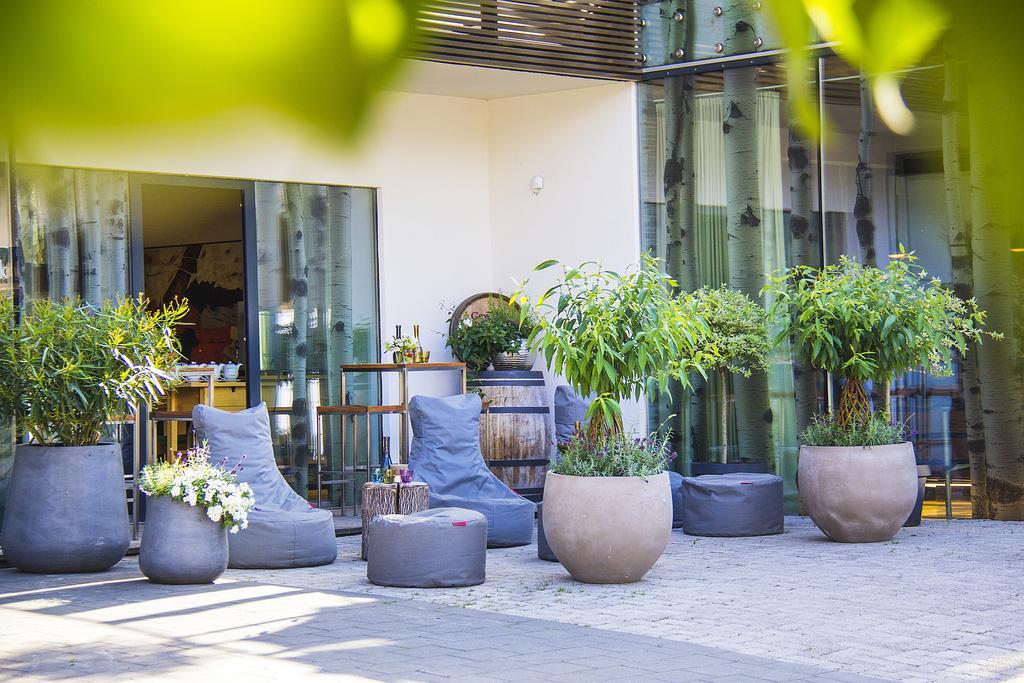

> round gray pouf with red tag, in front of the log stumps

[{"left": 367, "top": 508, "right": 487, "bottom": 588}]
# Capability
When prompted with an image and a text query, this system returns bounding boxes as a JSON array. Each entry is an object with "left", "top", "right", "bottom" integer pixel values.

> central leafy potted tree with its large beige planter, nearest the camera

[{"left": 513, "top": 256, "right": 710, "bottom": 584}]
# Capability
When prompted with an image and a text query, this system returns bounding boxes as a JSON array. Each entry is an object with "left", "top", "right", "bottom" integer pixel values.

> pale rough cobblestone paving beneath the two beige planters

[{"left": 229, "top": 517, "right": 1024, "bottom": 681}]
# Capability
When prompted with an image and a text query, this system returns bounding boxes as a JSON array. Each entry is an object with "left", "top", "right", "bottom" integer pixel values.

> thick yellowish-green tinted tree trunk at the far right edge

[{"left": 969, "top": 65, "right": 1024, "bottom": 519}]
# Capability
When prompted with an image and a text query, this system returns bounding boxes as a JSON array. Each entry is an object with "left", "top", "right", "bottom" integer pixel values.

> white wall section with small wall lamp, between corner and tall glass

[{"left": 489, "top": 83, "right": 646, "bottom": 430}]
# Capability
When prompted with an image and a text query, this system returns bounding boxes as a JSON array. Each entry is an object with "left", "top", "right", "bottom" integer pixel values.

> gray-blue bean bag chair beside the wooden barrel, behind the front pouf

[{"left": 409, "top": 394, "right": 536, "bottom": 548}]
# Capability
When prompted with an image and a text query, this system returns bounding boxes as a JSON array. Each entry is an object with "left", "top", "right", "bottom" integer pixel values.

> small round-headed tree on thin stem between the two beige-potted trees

[{"left": 689, "top": 285, "right": 771, "bottom": 463}]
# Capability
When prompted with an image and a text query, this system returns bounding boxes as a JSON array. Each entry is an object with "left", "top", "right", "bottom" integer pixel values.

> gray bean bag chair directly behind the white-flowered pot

[{"left": 193, "top": 403, "right": 338, "bottom": 569}]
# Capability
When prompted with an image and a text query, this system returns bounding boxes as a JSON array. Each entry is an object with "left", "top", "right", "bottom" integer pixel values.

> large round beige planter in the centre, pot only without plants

[{"left": 544, "top": 472, "right": 672, "bottom": 584}]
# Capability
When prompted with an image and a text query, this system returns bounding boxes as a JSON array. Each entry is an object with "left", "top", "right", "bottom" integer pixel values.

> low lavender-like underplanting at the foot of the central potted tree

[{"left": 551, "top": 433, "right": 676, "bottom": 477}]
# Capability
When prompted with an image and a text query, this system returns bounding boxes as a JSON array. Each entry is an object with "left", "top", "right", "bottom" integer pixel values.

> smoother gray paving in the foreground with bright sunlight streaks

[{"left": 0, "top": 562, "right": 870, "bottom": 683}]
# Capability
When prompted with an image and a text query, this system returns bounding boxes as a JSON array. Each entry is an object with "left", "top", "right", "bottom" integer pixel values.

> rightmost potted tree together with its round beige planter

[{"left": 766, "top": 246, "right": 1000, "bottom": 543}]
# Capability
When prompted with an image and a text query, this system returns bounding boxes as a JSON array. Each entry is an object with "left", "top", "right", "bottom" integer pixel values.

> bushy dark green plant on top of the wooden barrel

[{"left": 446, "top": 297, "right": 534, "bottom": 371}]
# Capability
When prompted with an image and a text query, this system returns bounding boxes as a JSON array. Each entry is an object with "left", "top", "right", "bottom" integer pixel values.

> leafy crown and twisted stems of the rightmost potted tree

[{"left": 765, "top": 246, "right": 1001, "bottom": 426}]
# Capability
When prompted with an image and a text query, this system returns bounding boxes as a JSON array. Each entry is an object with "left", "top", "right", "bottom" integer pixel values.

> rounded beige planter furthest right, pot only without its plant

[{"left": 799, "top": 442, "right": 918, "bottom": 543}]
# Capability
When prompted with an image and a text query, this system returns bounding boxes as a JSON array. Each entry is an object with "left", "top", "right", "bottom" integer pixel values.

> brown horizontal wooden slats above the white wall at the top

[{"left": 416, "top": 0, "right": 641, "bottom": 80}]
